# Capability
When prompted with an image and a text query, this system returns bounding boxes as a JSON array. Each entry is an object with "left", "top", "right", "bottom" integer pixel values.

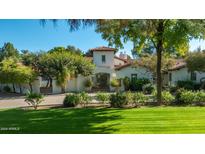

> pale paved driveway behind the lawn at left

[{"left": 0, "top": 93, "right": 65, "bottom": 109}]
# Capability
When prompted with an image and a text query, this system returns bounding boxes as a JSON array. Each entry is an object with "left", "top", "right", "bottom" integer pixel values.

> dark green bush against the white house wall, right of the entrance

[{"left": 130, "top": 78, "right": 150, "bottom": 91}]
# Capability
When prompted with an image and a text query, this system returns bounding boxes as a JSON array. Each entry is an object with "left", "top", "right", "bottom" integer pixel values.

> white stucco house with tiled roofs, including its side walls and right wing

[{"left": 0, "top": 46, "right": 205, "bottom": 94}]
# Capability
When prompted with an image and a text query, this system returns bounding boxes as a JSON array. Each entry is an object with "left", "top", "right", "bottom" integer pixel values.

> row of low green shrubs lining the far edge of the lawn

[{"left": 63, "top": 89, "right": 205, "bottom": 108}]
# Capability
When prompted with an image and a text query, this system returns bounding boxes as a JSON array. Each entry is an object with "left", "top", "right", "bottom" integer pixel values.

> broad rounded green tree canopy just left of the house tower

[{"left": 39, "top": 48, "right": 94, "bottom": 92}]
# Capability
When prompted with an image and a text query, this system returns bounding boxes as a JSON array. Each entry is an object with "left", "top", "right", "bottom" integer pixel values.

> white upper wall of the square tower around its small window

[{"left": 93, "top": 51, "right": 114, "bottom": 68}]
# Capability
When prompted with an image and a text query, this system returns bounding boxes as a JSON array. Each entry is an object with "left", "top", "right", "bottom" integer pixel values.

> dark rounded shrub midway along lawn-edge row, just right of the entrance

[{"left": 110, "top": 93, "right": 126, "bottom": 108}]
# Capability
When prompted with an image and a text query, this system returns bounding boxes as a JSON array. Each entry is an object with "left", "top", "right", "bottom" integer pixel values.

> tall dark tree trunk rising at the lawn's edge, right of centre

[{"left": 156, "top": 20, "right": 164, "bottom": 105}]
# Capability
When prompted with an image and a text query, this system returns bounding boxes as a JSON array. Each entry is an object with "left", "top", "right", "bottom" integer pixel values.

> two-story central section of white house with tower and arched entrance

[{"left": 84, "top": 47, "right": 152, "bottom": 91}]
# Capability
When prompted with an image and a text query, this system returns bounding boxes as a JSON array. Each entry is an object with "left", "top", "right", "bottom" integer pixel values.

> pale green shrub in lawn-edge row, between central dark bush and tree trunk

[{"left": 133, "top": 92, "right": 149, "bottom": 106}]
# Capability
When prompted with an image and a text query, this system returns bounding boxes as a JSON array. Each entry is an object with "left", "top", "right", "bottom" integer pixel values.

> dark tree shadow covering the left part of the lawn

[{"left": 0, "top": 108, "right": 121, "bottom": 134}]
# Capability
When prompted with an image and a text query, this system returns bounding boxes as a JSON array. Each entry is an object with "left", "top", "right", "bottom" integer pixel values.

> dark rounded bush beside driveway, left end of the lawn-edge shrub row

[{"left": 63, "top": 94, "right": 81, "bottom": 107}]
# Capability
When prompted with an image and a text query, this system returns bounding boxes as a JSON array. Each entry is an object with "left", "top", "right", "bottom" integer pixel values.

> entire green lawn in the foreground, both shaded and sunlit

[{"left": 0, "top": 107, "right": 205, "bottom": 134}]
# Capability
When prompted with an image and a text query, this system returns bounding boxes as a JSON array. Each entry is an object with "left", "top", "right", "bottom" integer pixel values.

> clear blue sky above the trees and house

[{"left": 0, "top": 19, "right": 205, "bottom": 54}]
